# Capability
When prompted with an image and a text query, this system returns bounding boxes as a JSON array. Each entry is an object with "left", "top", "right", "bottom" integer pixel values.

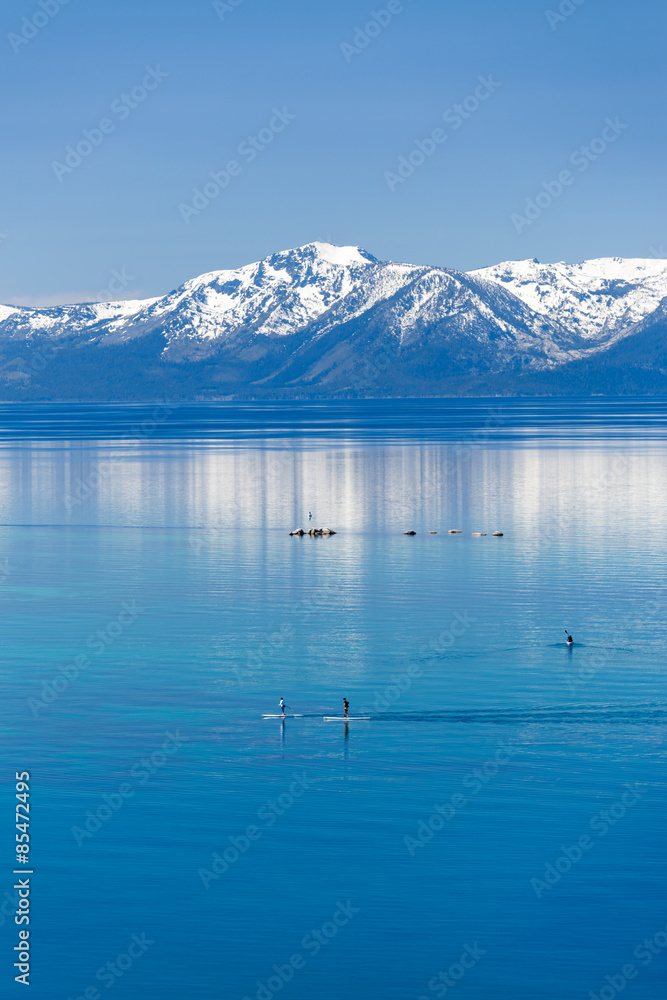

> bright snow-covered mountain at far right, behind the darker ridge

[{"left": 469, "top": 257, "right": 667, "bottom": 342}]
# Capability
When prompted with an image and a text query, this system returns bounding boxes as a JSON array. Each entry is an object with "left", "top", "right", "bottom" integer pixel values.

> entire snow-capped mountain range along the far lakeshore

[{"left": 0, "top": 243, "right": 667, "bottom": 401}]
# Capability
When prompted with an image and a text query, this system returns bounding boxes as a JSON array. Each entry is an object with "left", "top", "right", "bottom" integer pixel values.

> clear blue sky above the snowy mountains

[{"left": 0, "top": 0, "right": 667, "bottom": 303}]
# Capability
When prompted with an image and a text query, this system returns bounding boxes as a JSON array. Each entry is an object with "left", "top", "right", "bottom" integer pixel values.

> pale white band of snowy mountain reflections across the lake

[{"left": 0, "top": 442, "right": 667, "bottom": 544}]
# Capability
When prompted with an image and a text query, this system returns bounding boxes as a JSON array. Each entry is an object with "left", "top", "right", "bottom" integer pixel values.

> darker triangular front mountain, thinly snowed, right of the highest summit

[{"left": 252, "top": 265, "right": 590, "bottom": 395}]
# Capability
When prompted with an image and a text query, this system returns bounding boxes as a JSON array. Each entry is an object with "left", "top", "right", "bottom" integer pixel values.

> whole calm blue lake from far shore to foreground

[{"left": 0, "top": 400, "right": 667, "bottom": 1000}]
